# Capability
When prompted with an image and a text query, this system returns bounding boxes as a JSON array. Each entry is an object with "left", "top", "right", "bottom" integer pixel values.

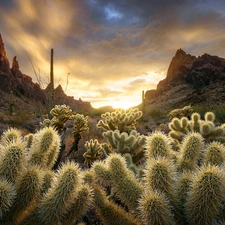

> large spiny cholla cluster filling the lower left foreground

[{"left": 0, "top": 128, "right": 93, "bottom": 225}]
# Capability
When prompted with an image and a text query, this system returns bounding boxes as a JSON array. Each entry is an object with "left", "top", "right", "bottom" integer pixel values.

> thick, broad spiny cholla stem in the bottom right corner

[{"left": 186, "top": 165, "right": 225, "bottom": 225}]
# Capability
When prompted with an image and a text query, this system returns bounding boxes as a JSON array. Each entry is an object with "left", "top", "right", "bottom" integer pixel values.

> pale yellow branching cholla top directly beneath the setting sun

[{"left": 97, "top": 108, "right": 142, "bottom": 133}]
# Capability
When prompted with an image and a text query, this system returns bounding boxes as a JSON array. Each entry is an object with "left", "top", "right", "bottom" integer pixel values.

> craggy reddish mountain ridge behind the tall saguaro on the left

[{"left": 0, "top": 34, "right": 92, "bottom": 113}]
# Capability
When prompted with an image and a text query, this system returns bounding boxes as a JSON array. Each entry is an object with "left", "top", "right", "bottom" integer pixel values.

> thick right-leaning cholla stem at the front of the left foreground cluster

[{"left": 37, "top": 163, "right": 81, "bottom": 225}]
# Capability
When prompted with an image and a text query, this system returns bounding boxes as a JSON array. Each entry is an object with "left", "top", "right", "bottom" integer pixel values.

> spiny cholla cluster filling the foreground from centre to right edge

[{"left": 88, "top": 128, "right": 225, "bottom": 225}]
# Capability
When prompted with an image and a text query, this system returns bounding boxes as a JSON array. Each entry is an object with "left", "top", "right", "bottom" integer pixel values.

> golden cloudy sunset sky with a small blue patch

[{"left": 0, "top": 0, "right": 225, "bottom": 108}]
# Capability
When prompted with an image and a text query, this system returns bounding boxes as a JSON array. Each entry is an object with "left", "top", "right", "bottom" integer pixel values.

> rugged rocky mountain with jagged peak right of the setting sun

[{"left": 145, "top": 49, "right": 225, "bottom": 110}]
